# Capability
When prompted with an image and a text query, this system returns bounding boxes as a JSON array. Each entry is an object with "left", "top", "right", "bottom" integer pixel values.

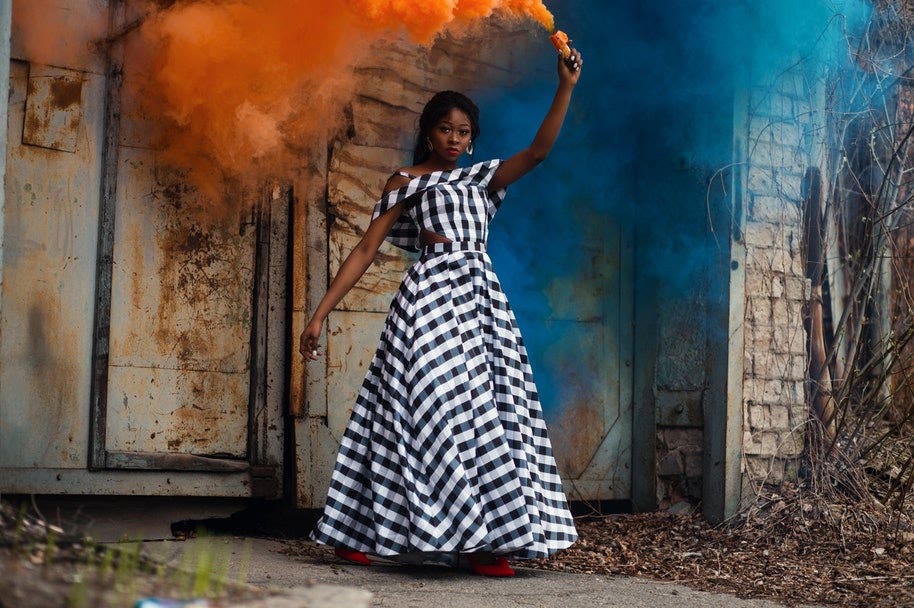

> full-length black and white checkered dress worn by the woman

[{"left": 313, "top": 160, "right": 577, "bottom": 559}]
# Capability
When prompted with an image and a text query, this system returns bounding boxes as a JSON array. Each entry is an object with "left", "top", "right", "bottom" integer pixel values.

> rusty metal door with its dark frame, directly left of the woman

[{"left": 91, "top": 157, "right": 288, "bottom": 484}]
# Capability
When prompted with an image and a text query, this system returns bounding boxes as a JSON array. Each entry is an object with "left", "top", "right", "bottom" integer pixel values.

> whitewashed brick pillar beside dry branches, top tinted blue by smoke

[{"left": 743, "top": 71, "right": 821, "bottom": 490}]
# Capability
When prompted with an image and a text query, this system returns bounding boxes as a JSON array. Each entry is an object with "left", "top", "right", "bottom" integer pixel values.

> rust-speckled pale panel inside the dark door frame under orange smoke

[{"left": 105, "top": 147, "right": 256, "bottom": 458}]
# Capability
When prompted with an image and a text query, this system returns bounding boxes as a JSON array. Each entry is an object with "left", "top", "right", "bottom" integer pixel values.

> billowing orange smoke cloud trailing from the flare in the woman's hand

[{"left": 125, "top": 0, "right": 552, "bottom": 192}]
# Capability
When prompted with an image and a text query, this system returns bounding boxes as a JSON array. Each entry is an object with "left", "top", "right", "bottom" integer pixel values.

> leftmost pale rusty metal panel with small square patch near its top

[{"left": 0, "top": 60, "right": 104, "bottom": 470}]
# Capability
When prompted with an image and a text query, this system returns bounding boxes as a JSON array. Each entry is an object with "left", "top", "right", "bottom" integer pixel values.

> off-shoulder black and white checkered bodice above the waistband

[{"left": 372, "top": 160, "right": 505, "bottom": 251}]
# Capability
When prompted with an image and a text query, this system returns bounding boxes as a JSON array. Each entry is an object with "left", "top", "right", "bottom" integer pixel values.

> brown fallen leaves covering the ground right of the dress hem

[{"left": 524, "top": 485, "right": 914, "bottom": 607}]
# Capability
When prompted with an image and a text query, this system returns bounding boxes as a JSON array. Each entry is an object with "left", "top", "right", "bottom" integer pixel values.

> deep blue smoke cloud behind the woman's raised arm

[{"left": 477, "top": 0, "right": 869, "bottom": 417}]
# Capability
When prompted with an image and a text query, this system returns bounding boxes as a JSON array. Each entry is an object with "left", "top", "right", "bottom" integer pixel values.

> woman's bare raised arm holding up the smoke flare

[{"left": 489, "top": 49, "right": 584, "bottom": 192}]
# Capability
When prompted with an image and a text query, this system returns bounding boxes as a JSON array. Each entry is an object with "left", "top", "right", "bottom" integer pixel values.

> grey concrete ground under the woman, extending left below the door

[{"left": 12, "top": 497, "right": 820, "bottom": 608}]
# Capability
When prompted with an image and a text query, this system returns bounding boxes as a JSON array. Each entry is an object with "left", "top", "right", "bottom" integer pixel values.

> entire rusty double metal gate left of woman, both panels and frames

[{"left": 0, "top": 0, "right": 284, "bottom": 497}]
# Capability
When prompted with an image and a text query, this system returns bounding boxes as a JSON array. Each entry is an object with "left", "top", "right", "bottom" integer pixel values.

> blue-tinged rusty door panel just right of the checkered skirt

[{"left": 512, "top": 221, "right": 632, "bottom": 500}]
